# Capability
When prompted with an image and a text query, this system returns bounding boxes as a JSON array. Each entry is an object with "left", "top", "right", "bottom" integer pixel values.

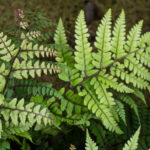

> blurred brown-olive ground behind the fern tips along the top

[{"left": 0, "top": 0, "right": 150, "bottom": 32}]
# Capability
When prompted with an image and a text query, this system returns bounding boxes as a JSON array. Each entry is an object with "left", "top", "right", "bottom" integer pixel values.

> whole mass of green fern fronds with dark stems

[{"left": 0, "top": 9, "right": 150, "bottom": 149}]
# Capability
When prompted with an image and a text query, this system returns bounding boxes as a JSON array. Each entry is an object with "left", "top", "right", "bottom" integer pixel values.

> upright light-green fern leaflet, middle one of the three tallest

[{"left": 92, "top": 9, "right": 112, "bottom": 68}]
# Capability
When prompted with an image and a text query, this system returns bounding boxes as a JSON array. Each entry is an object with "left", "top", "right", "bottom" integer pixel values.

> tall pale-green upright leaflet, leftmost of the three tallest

[{"left": 75, "top": 11, "right": 92, "bottom": 77}]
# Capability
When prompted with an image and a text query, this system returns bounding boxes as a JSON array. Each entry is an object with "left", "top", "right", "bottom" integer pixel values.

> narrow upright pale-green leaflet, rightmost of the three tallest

[{"left": 112, "top": 10, "right": 125, "bottom": 59}]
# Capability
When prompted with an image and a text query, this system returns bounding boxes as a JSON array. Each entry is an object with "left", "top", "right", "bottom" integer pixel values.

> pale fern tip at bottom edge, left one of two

[{"left": 85, "top": 130, "right": 98, "bottom": 150}]
